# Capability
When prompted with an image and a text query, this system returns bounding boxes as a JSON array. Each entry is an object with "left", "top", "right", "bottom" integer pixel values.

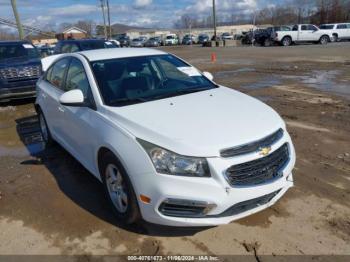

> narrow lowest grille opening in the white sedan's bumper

[{"left": 207, "top": 189, "right": 281, "bottom": 217}]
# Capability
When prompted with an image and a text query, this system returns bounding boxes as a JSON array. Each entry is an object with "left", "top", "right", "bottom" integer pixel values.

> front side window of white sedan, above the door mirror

[{"left": 65, "top": 58, "right": 92, "bottom": 101}]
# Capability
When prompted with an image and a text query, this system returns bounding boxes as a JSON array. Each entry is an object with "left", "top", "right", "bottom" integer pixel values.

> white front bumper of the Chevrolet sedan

[{"left": 140, "top": 132, "right": 295, "bottom": 227}]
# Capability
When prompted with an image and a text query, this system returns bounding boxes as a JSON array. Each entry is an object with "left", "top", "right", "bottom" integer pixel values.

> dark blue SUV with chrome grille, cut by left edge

[{"left": 0, "top": 41, "right": 41, "bottom": 102}]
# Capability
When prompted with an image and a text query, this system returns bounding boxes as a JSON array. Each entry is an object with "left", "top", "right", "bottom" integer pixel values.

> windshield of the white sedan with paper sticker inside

[{"left": 91, "top": 55, "right": 216, "bottom": 106}]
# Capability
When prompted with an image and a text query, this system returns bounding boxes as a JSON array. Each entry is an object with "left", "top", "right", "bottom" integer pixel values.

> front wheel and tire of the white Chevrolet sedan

[{"left": 100, "top": 152, "right": 141, "bottom": 225}]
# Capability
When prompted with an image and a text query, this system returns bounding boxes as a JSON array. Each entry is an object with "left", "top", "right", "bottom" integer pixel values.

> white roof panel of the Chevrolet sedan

[{"left": 78, "top": 48, "right": 167, "bottom": 61}]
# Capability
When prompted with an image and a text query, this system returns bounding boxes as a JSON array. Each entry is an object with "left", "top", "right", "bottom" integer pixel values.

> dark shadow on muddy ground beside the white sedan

[{"left": 16, "top": 115, "right": 208, "bottom": 237}]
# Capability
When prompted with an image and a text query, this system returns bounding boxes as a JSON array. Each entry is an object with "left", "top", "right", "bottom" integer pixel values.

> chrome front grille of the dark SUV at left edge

[{"left": 0, "top": 66, "right": 41, "bottom": 81}]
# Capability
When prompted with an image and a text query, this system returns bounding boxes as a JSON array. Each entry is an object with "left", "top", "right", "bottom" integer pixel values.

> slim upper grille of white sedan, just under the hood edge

[{"left": 220, "top": 128, "right": 283, "bottom": 158}]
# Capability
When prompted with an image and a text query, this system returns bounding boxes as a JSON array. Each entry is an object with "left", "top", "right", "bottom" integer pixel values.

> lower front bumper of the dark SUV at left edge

[{"left": 0, "top": 79, "right": 37, "bottom": 101}]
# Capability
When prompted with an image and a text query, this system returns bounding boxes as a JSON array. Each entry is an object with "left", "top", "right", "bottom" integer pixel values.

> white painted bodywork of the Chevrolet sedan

[{"left": 36, "top": 48, "right": 295, "bottom": 226}]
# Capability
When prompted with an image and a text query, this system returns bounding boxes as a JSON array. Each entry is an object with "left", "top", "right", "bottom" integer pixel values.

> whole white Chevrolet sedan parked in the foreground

[{"left": 35, "top": 48, "right": 295, "bottom": 226}]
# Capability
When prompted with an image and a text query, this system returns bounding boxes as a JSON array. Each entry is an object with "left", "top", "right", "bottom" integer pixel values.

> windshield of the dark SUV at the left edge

[{"left": 0, "top": 44, "right": 39, "bottom": 60}]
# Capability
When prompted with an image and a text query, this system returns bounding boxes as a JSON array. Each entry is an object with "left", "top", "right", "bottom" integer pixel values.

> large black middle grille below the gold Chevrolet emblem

[{"left": 226, "top": 143, "right": 289, "bottom": 186}]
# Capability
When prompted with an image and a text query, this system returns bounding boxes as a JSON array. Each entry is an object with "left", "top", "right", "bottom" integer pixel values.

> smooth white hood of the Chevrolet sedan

[{"left": 107, "top": 87, "right": 285, "bottom": 157}]
